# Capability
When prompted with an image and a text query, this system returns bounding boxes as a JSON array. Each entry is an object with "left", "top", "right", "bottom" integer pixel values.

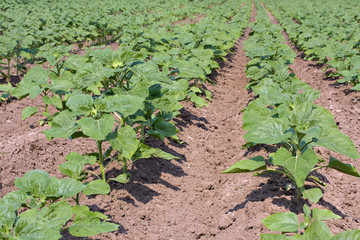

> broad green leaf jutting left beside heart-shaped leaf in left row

[{"left": 43, "top": 110, "right": 79, "bottom": 139}]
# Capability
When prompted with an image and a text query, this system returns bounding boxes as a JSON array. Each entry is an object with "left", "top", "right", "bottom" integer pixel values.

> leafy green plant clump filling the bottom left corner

[{"left": 0, "top": 170, "right": 119, "bottom": 240}]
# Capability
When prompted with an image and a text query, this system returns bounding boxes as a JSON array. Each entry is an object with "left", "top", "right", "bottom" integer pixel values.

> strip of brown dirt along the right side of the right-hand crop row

[{"left": 267, "top": 1, "right": 360, "bottom": 233}]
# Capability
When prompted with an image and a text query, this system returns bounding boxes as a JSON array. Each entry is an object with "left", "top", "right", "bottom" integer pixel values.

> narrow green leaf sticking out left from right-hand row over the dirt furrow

[{"left": 223, "top": 156, "right": 266, "bottom": 173}]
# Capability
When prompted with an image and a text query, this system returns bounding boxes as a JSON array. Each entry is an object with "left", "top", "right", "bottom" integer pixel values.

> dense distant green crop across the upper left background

[{"left": 0, "top": 1, "right": 239, "bottom": 81}]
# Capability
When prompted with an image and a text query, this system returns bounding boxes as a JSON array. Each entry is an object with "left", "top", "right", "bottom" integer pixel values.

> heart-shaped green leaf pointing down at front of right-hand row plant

[{"left": 273, "top": 148, "right": 317, "bottom": 187}]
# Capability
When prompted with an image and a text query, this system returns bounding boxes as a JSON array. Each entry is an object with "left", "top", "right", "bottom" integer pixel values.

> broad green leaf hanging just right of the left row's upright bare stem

[{"left": 107, "top": 126, "right": 140, "bottom": 159}]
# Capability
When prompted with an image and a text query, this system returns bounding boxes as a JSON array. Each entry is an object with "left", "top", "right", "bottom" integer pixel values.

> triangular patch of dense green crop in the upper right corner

[{"left": 265, "top": 0, "right": 360, "bottom": 91}]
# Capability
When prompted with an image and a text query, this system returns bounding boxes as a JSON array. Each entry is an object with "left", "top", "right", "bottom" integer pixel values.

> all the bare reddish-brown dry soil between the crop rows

[{"left": 0, "top": 2, "right": 360, "bottom": 240}]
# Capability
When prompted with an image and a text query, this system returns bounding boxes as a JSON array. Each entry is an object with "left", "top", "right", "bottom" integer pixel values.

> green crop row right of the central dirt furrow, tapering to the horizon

[{"left": 224, "top": 1, "right": 360, "bottom": 240}]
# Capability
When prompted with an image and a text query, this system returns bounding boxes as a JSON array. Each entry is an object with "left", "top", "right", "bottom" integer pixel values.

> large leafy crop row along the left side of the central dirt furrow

[{"left": 0, "top": 0, "right": 251, "bottom": 240}]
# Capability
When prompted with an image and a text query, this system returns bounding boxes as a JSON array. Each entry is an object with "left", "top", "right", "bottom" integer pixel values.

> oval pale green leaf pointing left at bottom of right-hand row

[{"left": 262, "top": 212, "right": 299, "bottom": 232}]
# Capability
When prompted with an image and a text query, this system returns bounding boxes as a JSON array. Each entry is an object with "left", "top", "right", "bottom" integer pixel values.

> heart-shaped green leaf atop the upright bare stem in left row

[{"left": 78, "top": 114, "right": 115, "bottom": 141}]
